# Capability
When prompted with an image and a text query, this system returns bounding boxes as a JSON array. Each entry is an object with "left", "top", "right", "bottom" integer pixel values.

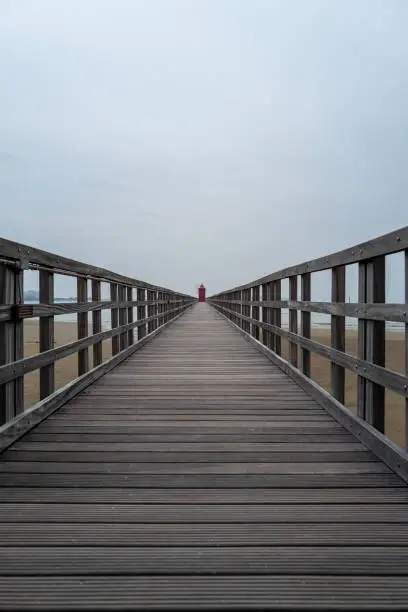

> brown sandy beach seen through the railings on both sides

[{"left": 24, "top": 320, "right": 405, "bottom": 446}]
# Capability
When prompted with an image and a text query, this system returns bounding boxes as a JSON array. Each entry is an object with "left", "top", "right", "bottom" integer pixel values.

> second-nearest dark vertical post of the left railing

[{"left": 40, "top": 270, "right": 55, "bottom": 399}]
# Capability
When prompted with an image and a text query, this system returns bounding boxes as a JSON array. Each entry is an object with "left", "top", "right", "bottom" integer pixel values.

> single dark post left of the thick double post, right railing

[{"left": 331, "top": 266, "right": 346, "bottom": 404}]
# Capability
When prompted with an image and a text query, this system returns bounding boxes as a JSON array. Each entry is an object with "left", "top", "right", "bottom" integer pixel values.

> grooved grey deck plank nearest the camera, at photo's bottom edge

[{"left": 0, "top": 574, "right": 408, "bottom": 610}]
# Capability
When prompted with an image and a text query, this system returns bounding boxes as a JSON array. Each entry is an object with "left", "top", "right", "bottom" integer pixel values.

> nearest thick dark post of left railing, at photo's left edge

[{"left": 0, "top": 262, "right": 24, "bottom": 425}]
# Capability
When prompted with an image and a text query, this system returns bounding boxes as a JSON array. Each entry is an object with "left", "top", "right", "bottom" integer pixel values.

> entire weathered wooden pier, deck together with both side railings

[{"left": 0, "top": 228, "right": 408, "bottom": 610}]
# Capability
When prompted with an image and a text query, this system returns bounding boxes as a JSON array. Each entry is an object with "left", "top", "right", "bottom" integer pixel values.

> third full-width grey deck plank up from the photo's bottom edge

[{"left": 0, "top": 520, "right": 408, "bottom": 544}]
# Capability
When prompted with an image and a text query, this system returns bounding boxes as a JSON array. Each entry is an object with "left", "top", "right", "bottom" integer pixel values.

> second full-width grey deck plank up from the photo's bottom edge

[{"left": 2, "top": 545, "right": 408, "bottom": 578}]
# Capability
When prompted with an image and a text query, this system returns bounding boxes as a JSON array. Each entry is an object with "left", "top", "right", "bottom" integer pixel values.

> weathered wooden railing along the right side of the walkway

[{"left": 209, "top": 227, "right": 408, "bottom": 470}]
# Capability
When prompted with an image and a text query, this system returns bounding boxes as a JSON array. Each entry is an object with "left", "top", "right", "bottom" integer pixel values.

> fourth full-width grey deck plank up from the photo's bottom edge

[{"left": 0, "top": 502, "right": 408, "bottom": 524}]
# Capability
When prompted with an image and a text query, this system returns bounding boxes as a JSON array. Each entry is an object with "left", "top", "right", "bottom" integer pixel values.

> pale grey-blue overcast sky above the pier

[{"left": 0, "top": 0, "right": 408, "bottom": 299}]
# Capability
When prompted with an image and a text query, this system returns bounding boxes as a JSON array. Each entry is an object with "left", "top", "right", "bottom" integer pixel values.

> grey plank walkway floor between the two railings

[{"left": 0, "top": 304, "right": 408, "bottom": 610}]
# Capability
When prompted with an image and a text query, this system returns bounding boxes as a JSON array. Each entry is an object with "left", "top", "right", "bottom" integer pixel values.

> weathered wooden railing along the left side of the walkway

[{"left": 0, "top": 239, "right": 196, "bottom": 440}]
